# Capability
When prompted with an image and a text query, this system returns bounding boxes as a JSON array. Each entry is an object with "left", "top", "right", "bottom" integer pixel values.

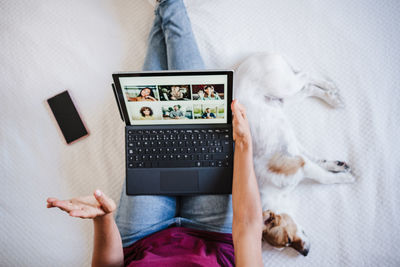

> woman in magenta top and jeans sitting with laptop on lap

[{"left": 47, "top": 0, "right": 263, "bottom": 266}]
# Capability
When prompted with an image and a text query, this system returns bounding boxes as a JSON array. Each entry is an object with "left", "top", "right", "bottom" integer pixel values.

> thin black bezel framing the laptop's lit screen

[{"left": 112, "top": 70, "right": 233, "bottom": 126}]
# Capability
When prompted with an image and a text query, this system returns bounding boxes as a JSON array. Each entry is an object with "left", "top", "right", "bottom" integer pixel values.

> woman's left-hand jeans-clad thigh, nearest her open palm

[{"left": 115, "top": 184, "right": 176, "bottom": 246}]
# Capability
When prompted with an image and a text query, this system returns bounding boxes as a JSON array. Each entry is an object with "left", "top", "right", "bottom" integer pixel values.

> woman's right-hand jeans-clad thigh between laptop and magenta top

[{"left": 179, "top": 195, "right": 233, "bottom": 232}]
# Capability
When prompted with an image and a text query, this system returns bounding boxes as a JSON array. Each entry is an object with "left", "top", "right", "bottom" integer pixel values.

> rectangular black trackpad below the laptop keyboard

[{"left": 160, "top": 170, "right": 199, "bottom": 192}]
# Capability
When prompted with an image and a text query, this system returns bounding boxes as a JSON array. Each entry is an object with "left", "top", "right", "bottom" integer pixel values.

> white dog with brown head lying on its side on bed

[{"left": 234, "top": 54, "right": 355, "bottom": 256}]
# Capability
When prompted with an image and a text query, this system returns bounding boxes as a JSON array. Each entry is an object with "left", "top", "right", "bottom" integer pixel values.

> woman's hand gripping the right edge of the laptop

[{"left": 231, "top": 99, "right": 251, "bottom": 148}]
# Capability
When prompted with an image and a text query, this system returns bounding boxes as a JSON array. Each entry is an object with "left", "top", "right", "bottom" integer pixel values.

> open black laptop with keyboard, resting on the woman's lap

[{"left": 112, "top": 70, "right": 233, "bottom": 196}]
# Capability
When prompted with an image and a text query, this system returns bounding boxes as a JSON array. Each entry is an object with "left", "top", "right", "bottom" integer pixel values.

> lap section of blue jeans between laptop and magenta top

[{"left": 115, "top": 186, "right": 232, "bottom": 247}]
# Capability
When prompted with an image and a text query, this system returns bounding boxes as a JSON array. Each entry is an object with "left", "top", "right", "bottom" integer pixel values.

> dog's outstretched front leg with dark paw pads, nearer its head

[{"left": 303, "top": 157, "right": 355, "bottom": 184}]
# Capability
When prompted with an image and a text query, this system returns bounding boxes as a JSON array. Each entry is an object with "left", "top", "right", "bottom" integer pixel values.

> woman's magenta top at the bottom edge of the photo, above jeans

[{"left": 124, "top": 227, "right": 235, "bottom": 267}]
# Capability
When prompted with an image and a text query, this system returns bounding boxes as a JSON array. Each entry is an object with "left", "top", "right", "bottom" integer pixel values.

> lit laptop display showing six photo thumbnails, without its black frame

[{"left": 119, "top": 73, "right": 229, "bottom": 125}]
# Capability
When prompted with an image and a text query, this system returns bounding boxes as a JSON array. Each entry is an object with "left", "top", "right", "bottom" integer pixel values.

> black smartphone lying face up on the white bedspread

[{"left": 47, "top": 91, "right": 89, "bottom": 144}]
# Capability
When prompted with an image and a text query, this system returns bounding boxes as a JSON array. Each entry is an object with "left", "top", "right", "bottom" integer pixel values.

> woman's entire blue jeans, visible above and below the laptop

[{"left": 115, "top": 0, "right": 232, "bottom": 247}]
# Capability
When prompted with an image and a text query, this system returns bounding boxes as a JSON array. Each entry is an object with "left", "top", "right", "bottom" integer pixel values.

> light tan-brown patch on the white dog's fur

[{"left": 268, "top": 153, "right": 305, "bottom": 175}]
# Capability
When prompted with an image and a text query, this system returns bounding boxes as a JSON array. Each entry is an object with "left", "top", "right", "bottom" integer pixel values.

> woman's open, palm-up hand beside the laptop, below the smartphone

[{"left": 47, "top": 190, "right": 116, "bottom": 219}]
